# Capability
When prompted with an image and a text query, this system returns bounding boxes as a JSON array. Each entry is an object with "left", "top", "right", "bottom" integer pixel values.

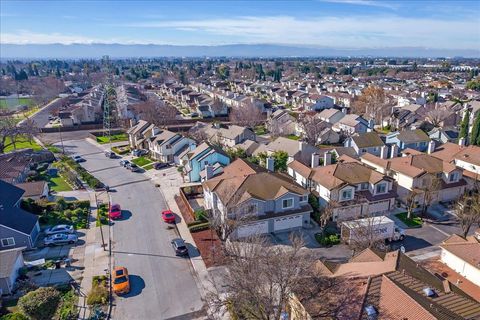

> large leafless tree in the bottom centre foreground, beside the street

[{"left": 207, "top": 235, "right": 313, "bottom": 320}]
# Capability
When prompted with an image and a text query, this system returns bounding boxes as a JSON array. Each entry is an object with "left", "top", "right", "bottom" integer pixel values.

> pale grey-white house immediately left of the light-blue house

[{"left": 148, "top": 128, "right": 195, "bottom": 164}]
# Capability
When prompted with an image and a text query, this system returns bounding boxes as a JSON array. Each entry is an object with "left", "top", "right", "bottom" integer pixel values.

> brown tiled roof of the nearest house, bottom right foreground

[{"left": 288, "top": 249, "right": 480, "bottom": 320}]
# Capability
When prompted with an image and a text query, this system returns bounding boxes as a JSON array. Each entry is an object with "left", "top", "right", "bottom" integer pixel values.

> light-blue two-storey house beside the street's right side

[{"left": 185, "top": 142, "right": 230, "bottom": 182}]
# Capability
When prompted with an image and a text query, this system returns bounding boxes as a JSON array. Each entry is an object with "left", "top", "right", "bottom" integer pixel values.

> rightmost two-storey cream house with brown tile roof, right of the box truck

[{"left": 360, "top": 149, "right": 467, "bottom": 205}]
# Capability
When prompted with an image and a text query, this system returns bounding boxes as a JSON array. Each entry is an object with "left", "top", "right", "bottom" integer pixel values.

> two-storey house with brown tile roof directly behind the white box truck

[{"left": 288, "top": 153, "right": 397, "bottom": 221}]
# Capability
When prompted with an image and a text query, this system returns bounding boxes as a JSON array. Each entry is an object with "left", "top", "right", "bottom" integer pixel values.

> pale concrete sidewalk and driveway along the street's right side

[{"left": 144, "top": 167, "right": 228, "bottom": 319}]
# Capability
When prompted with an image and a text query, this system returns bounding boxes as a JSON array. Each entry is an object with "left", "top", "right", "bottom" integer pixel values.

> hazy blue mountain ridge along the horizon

[{"left": 0, "top": 43, "right": 480, "bottom": 59}]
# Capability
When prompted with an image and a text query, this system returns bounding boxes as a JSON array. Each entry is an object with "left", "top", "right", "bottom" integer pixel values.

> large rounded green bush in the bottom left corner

[{"left": 18, "top": 287, "right": 60, "bottom": 320}]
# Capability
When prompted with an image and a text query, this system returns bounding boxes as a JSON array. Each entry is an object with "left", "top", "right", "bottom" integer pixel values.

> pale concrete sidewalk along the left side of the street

[{"left": 77, "top": 190, "right": 110, "bottom": 319}]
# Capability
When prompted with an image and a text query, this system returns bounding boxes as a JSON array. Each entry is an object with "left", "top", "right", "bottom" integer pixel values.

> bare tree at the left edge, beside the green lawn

[{"left": 0, "top": 117, "right": 38, "bottom": 153}]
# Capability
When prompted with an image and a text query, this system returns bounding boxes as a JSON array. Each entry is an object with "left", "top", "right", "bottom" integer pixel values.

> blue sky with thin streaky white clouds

[{"left": 0, "top": 0, "right": 480, "bottom": 49}]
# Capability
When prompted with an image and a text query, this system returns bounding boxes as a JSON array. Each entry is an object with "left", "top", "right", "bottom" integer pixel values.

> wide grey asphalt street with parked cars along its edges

[{"left": 64, "top": 140, "right": 203, "bottom": 320}]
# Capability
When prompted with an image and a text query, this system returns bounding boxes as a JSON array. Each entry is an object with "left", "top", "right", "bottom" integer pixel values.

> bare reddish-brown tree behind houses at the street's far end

[{"left": 134, "top": 98, "right": 177, "bottom": 128}]
